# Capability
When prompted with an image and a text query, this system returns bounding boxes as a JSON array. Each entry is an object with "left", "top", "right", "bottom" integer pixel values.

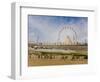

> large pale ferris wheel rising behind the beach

[{"left": 57, "top": 25, "right": 78, "bottom": 45}]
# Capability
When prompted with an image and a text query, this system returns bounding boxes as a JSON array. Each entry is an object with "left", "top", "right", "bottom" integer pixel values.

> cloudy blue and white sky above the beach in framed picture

[{"left": 28, "top": 15, "right": 88, "bottom": 43}]
